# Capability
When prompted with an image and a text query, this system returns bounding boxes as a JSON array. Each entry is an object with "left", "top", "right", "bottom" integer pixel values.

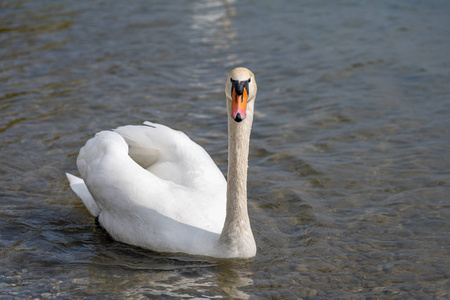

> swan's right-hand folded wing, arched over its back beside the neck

[{"left": 115, "top": 122, "right": 226, "bottom": 193}]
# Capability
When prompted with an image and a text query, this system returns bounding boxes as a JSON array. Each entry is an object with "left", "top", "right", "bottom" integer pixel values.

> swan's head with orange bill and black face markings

[{"left": 225, "top": 68, "right": 257, "bottom": 122}]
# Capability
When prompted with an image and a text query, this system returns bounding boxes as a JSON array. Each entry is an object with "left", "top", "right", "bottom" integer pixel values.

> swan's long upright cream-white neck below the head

[{"left": 219, "top": 101, "right": 256, "bottom": 257}]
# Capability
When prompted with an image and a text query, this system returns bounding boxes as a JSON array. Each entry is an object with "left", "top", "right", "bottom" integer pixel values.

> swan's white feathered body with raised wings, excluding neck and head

[{"left": 68, "top": 124, "right": 226, "bottom": 253}]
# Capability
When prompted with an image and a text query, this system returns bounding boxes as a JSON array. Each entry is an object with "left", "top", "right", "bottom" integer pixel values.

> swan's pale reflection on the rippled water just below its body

[{"left": 84, "top": 242, "right": 253, "bottom": 299}]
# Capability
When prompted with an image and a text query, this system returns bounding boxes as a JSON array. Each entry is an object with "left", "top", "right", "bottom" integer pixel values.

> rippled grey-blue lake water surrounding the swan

[{"left": 0, "top": 0, "right": 450, "bottom": 299}]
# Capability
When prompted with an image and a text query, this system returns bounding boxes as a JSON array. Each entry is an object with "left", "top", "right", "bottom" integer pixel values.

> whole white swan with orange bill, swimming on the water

[{"left": 67, "top": 68, "right": 257, "bottom": 258}]
